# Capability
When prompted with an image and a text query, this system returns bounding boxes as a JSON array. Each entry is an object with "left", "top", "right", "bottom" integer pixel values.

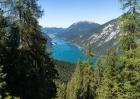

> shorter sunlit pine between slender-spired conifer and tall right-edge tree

[{"left": 95, "top": 51, "right": 117, "bottom": 99}]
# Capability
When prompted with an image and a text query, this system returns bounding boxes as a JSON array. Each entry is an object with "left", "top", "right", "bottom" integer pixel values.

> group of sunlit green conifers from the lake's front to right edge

[{"left": 56, "top": 0, "right": 140, "bottom": 99}]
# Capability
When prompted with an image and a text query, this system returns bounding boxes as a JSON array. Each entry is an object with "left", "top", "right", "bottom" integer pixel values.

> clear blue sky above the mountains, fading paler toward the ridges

[{"left": 38, "top": 0, "right": 122, "bottom": 28}]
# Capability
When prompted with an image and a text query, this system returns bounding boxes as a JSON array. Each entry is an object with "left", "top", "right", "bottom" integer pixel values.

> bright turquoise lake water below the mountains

[{"left": 52, "top": 38, "right": 85, "bottom": 63}]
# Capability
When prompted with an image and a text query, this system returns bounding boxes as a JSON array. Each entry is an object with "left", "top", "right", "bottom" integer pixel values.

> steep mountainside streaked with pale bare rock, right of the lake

[{"left": 84, "top": 19, "right": 120, "bottom": 56}]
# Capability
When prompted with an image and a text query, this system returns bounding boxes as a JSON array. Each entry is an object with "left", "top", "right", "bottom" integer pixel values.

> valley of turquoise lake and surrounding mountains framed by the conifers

[{"left": 43, "top": 19, "right": 119, "bottom": 59}]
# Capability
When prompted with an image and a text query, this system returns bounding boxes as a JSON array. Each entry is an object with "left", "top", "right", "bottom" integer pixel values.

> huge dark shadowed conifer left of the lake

[{"left": 0, "top": 0, "right": 57, "bottom": 99}]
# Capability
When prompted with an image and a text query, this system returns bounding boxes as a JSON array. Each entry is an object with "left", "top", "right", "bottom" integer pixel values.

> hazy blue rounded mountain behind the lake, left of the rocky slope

[{"left": 57, "top": 21, "right": 100, "bottom": 41}]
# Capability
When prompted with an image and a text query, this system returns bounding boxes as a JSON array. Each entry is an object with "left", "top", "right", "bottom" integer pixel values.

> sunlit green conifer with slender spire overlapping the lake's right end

[{"left": 66, "top": 46, "right": 95, "bottom": 99}]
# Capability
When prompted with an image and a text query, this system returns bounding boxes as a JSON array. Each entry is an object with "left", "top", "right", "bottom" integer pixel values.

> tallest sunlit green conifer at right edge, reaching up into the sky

[{"left": 118, "top": 0, "right": 140, "bottom": 99}]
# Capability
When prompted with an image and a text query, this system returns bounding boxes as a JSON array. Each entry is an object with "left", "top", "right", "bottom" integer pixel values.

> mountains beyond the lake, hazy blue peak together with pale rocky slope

[{"left": 58, "top": 19, "right": 119, "bottom": 56}]
